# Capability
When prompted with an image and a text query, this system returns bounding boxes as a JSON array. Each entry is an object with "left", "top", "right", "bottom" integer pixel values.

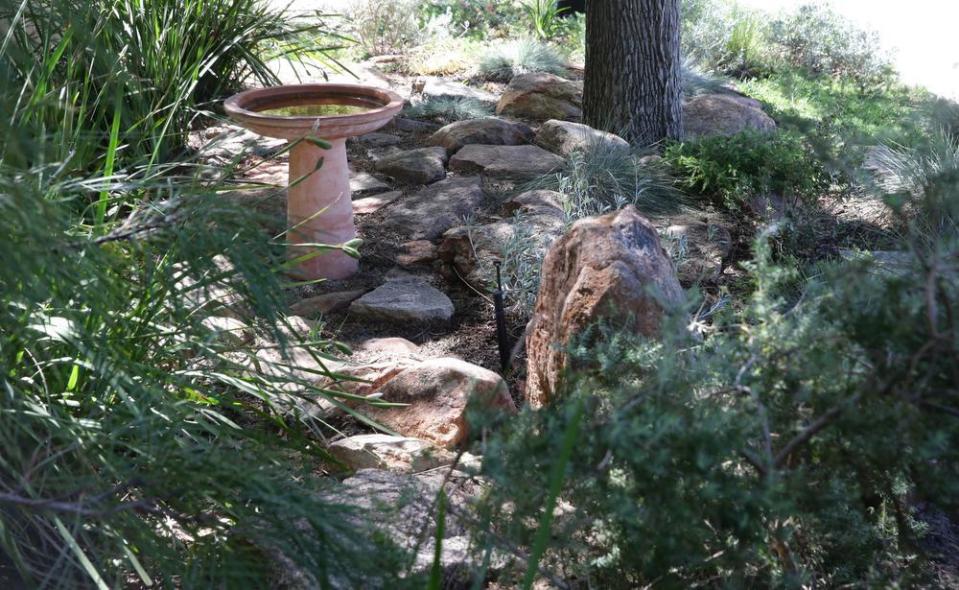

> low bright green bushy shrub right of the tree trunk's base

[{"left": 665, "top": 132, "right": 829, "bottom": 211}]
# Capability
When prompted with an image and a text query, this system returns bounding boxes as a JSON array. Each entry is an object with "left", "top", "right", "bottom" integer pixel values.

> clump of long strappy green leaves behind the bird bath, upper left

[{"left": 0, "top": 0, "right": 314, "bottom": 176}]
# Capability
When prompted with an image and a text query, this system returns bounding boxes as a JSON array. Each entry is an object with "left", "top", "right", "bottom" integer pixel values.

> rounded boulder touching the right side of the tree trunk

[{"left": 683, "top": 94, "right": 776, "bottom": 139}]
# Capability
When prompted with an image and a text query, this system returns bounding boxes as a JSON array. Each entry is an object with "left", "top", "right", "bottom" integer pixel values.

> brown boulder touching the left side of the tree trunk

[{"left": 496, "top": 72, "right": 583, "bottom": 121}]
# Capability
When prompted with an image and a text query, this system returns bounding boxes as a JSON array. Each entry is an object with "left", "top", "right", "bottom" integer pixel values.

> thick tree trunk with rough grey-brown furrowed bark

[{"left": 583, "top": 0, "right": 683, "bottom": 145}]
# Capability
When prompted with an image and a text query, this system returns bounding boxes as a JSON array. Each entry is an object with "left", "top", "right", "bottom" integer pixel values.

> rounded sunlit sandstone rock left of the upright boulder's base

[{"left": 368, "top": 358, "right": 516, "bottom": 448}]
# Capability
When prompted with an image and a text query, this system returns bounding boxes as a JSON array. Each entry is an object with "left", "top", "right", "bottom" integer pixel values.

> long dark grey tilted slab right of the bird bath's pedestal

[{"left": 384, "top": 177, "right": 486, "bottom": 240}]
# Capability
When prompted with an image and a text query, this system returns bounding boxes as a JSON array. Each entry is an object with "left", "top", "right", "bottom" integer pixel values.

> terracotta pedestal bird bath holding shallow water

[{"left": 223, "top": 84, "right": 403, "bottom": 279}]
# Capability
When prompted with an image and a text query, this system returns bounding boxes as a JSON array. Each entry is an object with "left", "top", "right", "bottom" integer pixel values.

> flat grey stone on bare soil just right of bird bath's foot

[{"left": 350, "top": 277, "right": 455, "bottom": 323}]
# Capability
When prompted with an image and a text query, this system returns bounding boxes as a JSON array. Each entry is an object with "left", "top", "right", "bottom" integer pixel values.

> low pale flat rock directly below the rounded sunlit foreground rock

[{"left": 327, "top": 434, "right": 455, "bottom": 473}]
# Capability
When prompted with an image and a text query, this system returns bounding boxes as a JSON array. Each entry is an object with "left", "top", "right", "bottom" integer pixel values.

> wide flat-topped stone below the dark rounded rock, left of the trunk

[{"left": 450, "top": 145, "right": 565, "bottom": 180}]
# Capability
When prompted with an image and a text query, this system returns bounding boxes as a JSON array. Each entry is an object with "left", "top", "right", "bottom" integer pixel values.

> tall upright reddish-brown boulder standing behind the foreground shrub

[{"left": 526, "top": 205, "right": 683, "bottom": 407}]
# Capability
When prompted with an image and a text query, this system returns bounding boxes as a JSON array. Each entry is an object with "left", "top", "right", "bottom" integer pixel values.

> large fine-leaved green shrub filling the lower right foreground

[{"left": 470, "top": 184, "right": 959, "bottom": 588}]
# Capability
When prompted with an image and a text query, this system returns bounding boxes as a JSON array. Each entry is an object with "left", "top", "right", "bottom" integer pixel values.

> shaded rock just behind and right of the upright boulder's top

[{"left": 661, "top": 216, "right": 733, "bottom": 287}]
